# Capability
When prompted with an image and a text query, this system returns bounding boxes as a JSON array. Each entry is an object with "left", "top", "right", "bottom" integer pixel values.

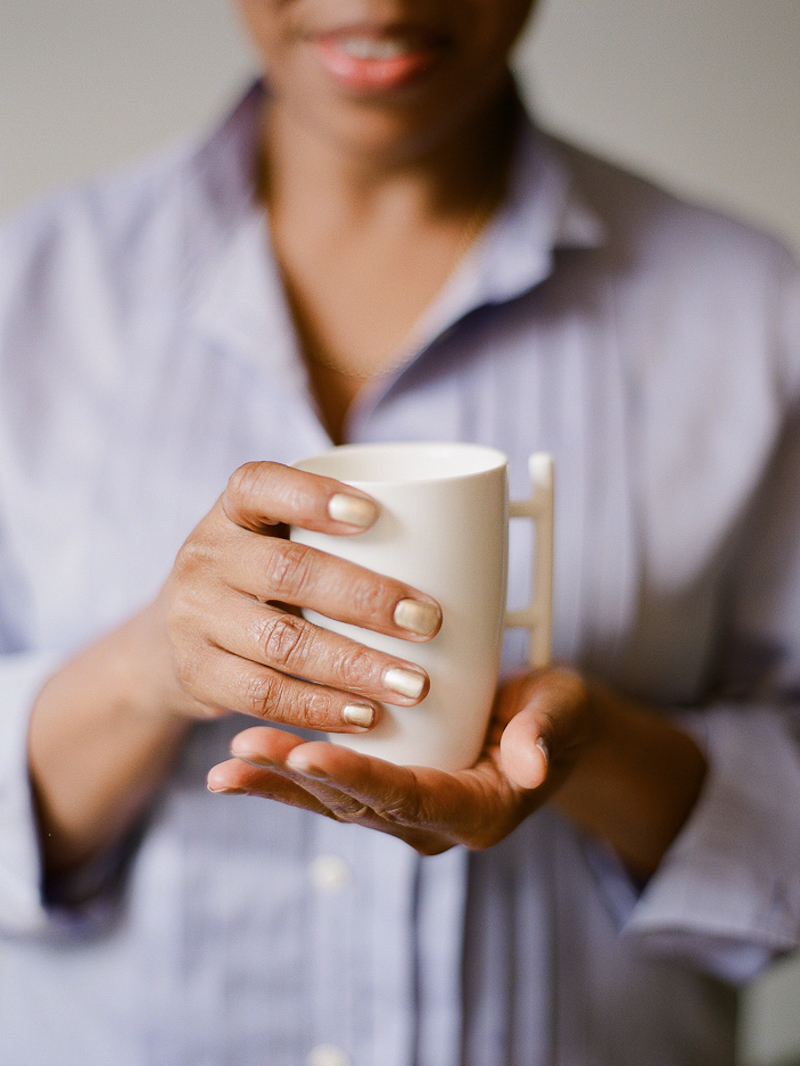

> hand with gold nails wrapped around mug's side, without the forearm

[{"left": 156, "top": 463, "right": 442, "bottom": 732}]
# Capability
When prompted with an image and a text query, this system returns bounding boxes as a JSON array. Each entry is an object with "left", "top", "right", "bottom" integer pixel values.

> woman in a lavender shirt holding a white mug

[{"left": 0, "top": 0, "right": 800, "bottom": 1066}]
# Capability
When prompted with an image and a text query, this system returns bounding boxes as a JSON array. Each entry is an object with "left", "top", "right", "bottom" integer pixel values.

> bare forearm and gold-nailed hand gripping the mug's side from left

[{"left": 29, "top": 463, "right": 441, "bottom": 872}]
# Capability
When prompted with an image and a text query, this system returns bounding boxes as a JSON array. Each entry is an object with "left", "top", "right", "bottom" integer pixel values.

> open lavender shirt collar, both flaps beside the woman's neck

[{"left": 188, "top": 83, "right": 605, "bottom": 384}]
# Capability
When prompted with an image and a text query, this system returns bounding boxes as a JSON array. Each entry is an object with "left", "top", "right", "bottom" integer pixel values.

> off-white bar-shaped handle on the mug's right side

[{"left": 506, "top": 452, "right": 553, "bottom": 669}]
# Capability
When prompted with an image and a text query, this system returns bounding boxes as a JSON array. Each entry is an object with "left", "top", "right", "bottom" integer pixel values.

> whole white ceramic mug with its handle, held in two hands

[{"left": 291, "top": 442, "right": 553, "bottom": 770}]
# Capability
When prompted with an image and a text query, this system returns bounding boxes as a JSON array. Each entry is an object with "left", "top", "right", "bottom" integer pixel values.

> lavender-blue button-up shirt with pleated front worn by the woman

[{"left": 0, "top": 88, "right": 800, "bottom": 1066}]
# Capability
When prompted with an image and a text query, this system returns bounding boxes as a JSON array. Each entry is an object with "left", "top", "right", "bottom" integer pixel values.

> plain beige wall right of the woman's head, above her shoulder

[{"left": 522, "top": 0, "right": 800, "bottom": 255}]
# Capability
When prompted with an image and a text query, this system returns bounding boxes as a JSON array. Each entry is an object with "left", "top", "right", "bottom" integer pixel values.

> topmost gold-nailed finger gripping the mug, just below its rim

[{"left": 222, "top": 463, "right": 378, "bottom": 535}]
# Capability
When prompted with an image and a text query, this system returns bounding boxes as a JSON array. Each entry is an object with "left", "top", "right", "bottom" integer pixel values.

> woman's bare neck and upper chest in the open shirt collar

[{"left": 261, "top": 76, "right": 519, "bottom": 441}]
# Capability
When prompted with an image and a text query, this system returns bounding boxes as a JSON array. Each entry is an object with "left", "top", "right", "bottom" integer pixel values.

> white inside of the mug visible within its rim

[{"left": 293, "top": 441, "right": 508, "bottom": 482}]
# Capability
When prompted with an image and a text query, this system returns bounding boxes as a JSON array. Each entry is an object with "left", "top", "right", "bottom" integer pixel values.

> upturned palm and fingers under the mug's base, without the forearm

[{"left": 208, "top": 667, "right": 594, "bottom": 855}]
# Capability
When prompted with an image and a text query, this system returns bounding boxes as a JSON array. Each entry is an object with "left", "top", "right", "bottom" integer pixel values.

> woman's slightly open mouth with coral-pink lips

[{"left": 314, "top": 27, "right": 444, "bottom": 92}]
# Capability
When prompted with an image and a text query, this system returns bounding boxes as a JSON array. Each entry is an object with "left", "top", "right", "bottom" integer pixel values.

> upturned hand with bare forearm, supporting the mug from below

[{"left": 208, "top": 667, "right": 706, "bottom": 881}]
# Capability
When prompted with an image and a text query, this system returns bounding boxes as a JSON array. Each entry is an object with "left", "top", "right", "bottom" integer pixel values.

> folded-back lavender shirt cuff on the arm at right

[{"left": 602, "top": 707, "right": 800, "bottom": 983}]
